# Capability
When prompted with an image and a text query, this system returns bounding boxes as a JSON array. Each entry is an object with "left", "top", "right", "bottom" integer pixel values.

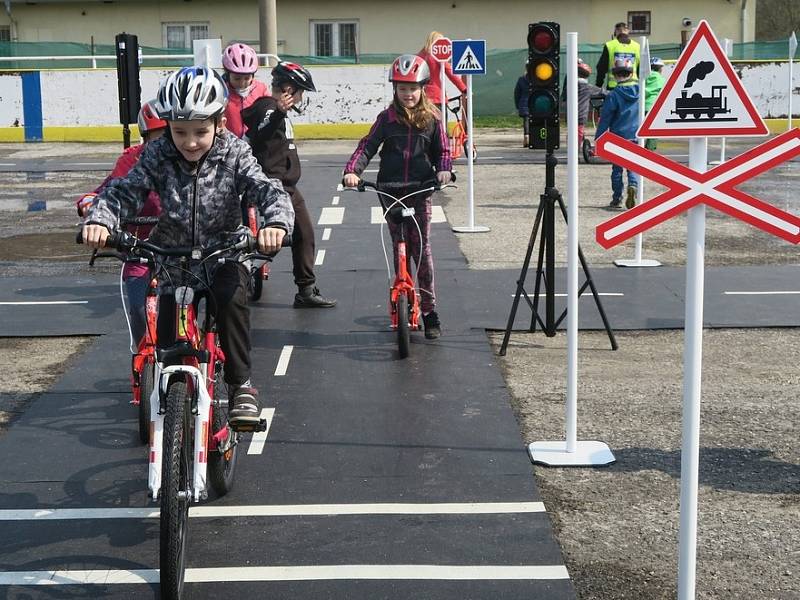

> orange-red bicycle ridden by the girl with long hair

[{"left": 344, "top": 174, "right": 456, "bottom": 358}]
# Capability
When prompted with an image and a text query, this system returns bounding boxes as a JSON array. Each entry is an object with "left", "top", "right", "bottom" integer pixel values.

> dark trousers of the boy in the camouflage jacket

[{"left": 158, "top": 263, "right": 251, "bottom": 385}]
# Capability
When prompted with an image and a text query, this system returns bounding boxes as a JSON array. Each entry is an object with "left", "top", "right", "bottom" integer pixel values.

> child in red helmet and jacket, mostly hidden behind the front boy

[{"left": 77, "top": 100, "right": 167, "bottom": 349}]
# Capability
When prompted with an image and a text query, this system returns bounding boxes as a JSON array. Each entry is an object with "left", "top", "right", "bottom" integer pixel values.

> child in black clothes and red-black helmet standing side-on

[{"left": 242, "top": 62, "right": 336, "bottom": 308}]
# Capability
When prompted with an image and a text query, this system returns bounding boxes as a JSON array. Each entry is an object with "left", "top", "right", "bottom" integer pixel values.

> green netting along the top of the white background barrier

[{"left": 0, "top": 40, "right": 788, "bottom": 116}]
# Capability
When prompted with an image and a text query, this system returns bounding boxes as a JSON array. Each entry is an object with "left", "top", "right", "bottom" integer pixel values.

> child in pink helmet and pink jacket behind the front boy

[{"left": 222, "top": 43, "right": 269, "bottom": 138}]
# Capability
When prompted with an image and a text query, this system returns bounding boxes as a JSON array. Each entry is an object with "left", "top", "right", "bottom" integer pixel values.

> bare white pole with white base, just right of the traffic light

[{"left": 528, "top": 32, "right": 616, "bottom": 467}]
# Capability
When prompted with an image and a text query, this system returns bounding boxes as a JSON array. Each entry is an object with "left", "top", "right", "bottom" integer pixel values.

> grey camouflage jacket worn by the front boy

[{"left": 86, "top": 131, "right": 294, "bottom": 252}]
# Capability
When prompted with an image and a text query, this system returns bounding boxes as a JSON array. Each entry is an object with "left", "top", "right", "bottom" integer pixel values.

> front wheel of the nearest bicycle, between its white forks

[{"left": 159, "top": 381, "right": 192, "bottom": 600}]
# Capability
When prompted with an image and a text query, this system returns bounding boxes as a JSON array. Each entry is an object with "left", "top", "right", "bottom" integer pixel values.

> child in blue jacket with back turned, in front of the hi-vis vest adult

[{"left": 595, "top": 59, "right": 639, "bottom": 208}]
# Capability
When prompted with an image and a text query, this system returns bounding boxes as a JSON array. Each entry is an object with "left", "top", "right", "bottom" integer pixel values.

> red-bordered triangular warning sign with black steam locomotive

[{"left": 637, "top": 21, "right": 769, "bottom": 138}]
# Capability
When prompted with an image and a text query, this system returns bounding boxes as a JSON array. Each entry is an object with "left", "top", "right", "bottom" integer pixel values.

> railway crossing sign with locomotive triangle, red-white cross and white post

[{"left": 596, "top": 21, "right": 800, "bottom": 600}]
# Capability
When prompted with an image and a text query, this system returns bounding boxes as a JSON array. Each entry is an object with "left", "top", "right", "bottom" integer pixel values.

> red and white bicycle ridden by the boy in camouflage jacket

[{"left": 83, "top": 228, "right": 284, "bottom": 599}]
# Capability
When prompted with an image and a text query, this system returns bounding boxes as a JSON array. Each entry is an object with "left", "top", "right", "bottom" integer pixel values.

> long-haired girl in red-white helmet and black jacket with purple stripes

[{"left": 343, "top": 54, "right": 452, "bottom": 339}]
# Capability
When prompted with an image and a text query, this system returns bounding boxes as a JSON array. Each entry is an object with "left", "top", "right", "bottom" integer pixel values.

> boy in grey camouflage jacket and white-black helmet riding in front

[{"left": 83, "top": 66, "right": 294, "bottom": 429}]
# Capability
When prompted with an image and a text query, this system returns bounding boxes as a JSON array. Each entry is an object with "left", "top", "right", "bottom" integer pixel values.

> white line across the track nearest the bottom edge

[{"left": 0, "top": 565, "right": 569, "bottom": 585}]
